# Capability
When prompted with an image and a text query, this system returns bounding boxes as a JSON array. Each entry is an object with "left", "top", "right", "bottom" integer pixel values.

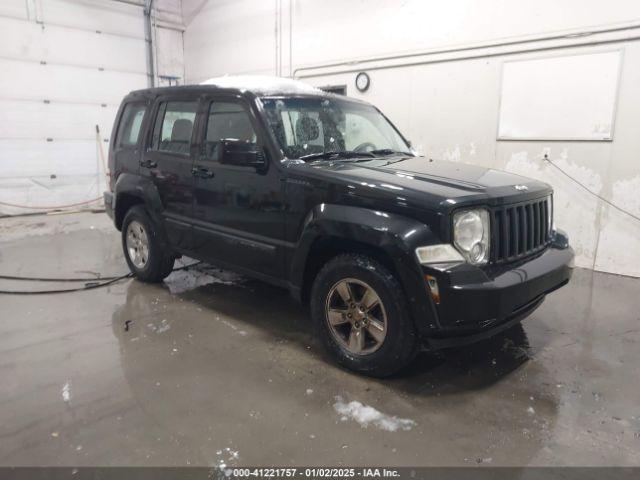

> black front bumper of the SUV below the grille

[{"left": 423, "top": 236, "right": 574, "bottom": 348}]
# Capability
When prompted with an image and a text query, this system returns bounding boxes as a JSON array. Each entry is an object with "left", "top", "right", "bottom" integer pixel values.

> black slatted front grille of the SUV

[{"left": 491, "top": 197, "right": 553, "bottom": 263}]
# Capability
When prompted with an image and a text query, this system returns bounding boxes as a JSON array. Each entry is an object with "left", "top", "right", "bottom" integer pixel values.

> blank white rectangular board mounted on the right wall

[{"left": 498, "top": 50, "right": 621, "bottom": 141}]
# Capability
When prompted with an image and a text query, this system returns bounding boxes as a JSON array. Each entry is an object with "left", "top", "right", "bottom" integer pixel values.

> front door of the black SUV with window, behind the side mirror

[{"left": 193, "top": 97, "right": 284, "bottom": 278}]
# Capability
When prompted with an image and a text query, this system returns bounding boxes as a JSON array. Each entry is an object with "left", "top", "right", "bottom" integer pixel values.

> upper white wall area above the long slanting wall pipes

[{"left": 183, "top": 0, "right": 640, "bottom": 81}]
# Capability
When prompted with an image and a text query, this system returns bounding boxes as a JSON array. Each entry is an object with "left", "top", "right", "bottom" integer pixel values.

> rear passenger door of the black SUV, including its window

[{"left": 140, "top": 93, "right": 198, "bottom": 252}]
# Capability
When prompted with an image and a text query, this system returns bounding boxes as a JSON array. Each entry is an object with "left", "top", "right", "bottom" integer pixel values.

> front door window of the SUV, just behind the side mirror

[{"left": 205, "top": 102, "right": 257, "bottom": 161}]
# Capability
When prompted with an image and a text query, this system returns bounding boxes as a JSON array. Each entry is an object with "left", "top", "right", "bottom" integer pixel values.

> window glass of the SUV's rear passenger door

[{"left": 151, "top": 102, "right": 198, "bottom": 154}]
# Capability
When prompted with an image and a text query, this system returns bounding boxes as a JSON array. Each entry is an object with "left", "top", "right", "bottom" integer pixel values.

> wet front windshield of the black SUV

[{"left": 262, "top": 97, "right": 412, "bottom": 159}]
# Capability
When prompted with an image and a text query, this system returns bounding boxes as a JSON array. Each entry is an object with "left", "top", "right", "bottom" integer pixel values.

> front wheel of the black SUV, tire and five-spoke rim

[{"left": 311, "top": 254, "right": 417, "bottom": 377}]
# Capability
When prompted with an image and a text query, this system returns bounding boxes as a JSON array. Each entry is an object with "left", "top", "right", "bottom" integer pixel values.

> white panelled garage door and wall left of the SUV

[{"left": 0, "top": 0, "right": 184, "bottom": 214}]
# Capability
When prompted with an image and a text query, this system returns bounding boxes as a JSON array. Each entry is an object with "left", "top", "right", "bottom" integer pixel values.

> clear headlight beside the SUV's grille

[{"left": 453, "top": 209, "right": 490, "bottom": 265}]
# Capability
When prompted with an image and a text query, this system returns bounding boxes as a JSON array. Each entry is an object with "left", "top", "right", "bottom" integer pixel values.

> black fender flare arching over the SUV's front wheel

[{"left": 290, "top": 204, "right": 439, "bottom": 333}]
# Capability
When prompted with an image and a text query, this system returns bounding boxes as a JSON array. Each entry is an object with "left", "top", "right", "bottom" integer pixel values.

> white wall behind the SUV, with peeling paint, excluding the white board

[{"left": 184, "top": 0, "right": 640, "bottom": 276}]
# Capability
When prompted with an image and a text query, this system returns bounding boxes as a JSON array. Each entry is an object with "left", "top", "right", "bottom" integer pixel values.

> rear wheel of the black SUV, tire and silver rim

[{"left": 122, "top": 205, "right": 174, "bottom": 283}]
